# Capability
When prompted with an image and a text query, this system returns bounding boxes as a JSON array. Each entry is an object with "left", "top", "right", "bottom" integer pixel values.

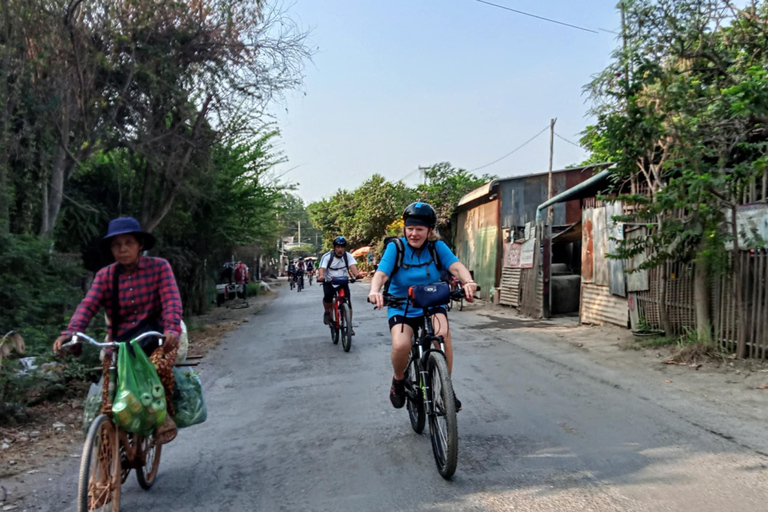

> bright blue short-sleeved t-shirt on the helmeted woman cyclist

[{"left": 379, "top": 238, "right": 459, "bottom": 318}]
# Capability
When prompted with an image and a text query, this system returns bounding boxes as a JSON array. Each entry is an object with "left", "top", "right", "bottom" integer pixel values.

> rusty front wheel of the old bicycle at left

[{"left": 77, "top": 414, "right": 122, "bottom": 512}]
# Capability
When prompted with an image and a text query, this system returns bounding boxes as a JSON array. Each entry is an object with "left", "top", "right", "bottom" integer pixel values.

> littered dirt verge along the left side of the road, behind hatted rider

[{"left": 0, "top": 282, "right": 280, "bottom": 486}]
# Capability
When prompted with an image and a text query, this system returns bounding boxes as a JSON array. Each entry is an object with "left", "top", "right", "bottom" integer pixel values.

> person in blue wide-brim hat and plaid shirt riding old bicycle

[{"left": 53, "top": 217, "right": 182, "bottom": 440}]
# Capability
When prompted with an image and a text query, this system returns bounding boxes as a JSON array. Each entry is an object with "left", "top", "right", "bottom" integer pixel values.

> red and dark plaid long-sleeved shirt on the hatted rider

[{"left": 62, "top": 256, "right": 182, "bottom": 337}]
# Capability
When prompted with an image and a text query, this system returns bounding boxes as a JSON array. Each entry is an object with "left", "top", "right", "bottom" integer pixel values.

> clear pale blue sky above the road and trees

[{"left": 273, "top": 0, "right": 620, "bottom": 202}]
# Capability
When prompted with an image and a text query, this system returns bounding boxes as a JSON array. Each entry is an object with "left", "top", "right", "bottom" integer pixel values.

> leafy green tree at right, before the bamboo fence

[{"left": 583, "top": 0, "right": 768, "bottom": 356}]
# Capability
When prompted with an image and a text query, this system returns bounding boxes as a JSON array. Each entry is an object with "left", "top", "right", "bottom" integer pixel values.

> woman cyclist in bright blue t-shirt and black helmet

[{"left": 368, "top": 203, "right": 477, "bottom": 411}]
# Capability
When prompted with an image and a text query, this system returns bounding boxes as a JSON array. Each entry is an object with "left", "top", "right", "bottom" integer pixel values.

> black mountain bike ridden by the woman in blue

[{"left": 376, "top": 285, "right": 476, "bottom": 480}]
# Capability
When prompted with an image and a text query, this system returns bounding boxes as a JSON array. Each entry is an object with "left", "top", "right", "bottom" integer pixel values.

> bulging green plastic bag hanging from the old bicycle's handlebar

[{"left": 112, "top": 342, "right": 167, "bottom": 436}]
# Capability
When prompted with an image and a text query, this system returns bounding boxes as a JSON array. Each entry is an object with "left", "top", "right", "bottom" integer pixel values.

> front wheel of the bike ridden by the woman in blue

[{"left": 427, "top": 352, "right": 459, "bottom": 480}]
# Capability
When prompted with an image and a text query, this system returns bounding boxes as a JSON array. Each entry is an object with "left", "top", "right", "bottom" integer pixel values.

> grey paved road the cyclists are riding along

[{"left": 21, "top": 284, "right": 768, "bottom": 512}]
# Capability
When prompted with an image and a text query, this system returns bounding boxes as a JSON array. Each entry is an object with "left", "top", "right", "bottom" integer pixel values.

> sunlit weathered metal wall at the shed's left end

[{"left": 456, "top": 199, "right": 502, "bottom": 300}]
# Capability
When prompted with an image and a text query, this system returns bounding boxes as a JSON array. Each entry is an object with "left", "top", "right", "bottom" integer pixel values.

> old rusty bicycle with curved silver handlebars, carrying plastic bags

[{"left": 62, "top": 331, "right": 165, "bottom": 512}]
